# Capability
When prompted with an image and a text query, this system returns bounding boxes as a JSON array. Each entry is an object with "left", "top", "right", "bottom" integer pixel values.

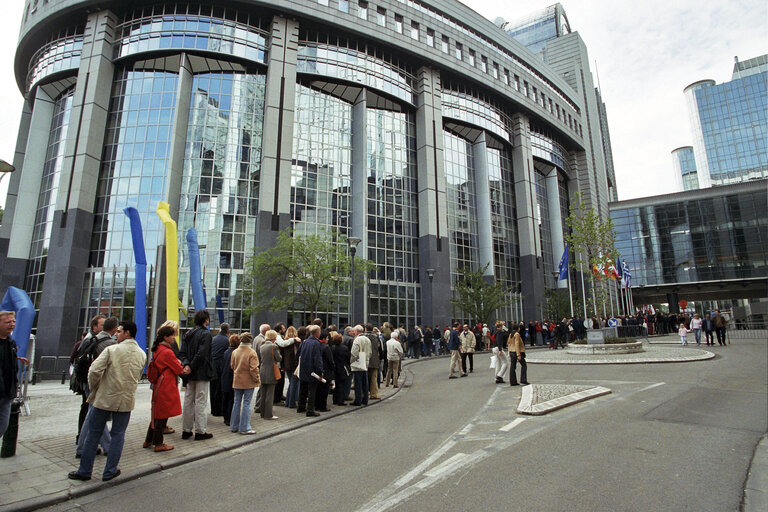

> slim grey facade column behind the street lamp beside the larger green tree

[{"left": 350, "top": 89, "right": 368, "bottom": 325}]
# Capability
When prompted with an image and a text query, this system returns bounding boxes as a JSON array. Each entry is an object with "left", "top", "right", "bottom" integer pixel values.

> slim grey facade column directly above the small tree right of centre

[{"left": 472, "top": 132, "right": 496, "bottom": 282}]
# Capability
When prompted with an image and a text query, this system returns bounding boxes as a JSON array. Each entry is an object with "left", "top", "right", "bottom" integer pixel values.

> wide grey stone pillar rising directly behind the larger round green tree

[{"left": 254, "top": 16, "right": 299, "bottom": 326}]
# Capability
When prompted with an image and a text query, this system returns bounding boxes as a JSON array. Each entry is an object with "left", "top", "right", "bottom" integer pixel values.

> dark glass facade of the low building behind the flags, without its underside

[{"left": 611, "top": 190, "right": 768, "bottom": 286}]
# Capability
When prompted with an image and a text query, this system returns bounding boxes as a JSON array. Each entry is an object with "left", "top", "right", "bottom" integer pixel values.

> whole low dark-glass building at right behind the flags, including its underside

[{"left": 610, "top": 180, "right": 768, "bottom": 304}]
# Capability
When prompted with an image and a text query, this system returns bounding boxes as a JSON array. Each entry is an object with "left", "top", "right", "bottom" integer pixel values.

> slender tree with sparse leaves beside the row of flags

[{"left": 565, "top": 194, "right": 620, "bottom": 314}]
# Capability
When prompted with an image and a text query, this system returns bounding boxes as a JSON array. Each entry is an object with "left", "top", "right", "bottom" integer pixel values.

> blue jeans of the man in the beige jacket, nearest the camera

[{"left": 77, "top": 406, "right": 131, "bottom": 478}]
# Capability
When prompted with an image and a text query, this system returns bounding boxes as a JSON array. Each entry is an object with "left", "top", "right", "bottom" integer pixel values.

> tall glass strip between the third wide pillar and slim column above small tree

[{"left": 443, "top": 130, "right": 480, "bottom": 321}]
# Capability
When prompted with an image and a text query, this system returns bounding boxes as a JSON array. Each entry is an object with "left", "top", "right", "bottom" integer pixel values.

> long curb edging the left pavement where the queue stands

[{"left": 3, "top": 362, "right": 424, "bottom": 512}]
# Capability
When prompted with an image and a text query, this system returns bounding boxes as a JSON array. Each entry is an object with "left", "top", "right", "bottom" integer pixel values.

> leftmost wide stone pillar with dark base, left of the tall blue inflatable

[{"left": 37, "top": 11, "right": 115, "bottom": 356}]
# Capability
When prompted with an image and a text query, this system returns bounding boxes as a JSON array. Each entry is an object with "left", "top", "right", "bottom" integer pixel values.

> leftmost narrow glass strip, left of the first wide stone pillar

[{"left": 24, "top": 87, "right": 75, "bottom": 310}]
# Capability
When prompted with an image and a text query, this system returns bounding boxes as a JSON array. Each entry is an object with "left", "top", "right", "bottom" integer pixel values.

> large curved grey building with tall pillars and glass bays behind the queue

[{"left": 0, "top": 0, "right": 608, "bottom": 362}]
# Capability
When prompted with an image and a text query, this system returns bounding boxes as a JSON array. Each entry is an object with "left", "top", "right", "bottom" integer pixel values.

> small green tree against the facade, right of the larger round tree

[{"left": 451, "top": 263, "right": 515, "bottom": 323}]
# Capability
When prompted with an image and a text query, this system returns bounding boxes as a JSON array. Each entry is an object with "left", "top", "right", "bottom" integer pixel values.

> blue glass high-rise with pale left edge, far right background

[{"left": 681, "top": 55, "right": 768, "bottom": 188}]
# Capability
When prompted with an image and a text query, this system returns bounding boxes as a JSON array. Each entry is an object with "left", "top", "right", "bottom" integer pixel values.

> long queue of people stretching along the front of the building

[{"left": 61, "top": 310, "right": 726, "bottom": 481}]
